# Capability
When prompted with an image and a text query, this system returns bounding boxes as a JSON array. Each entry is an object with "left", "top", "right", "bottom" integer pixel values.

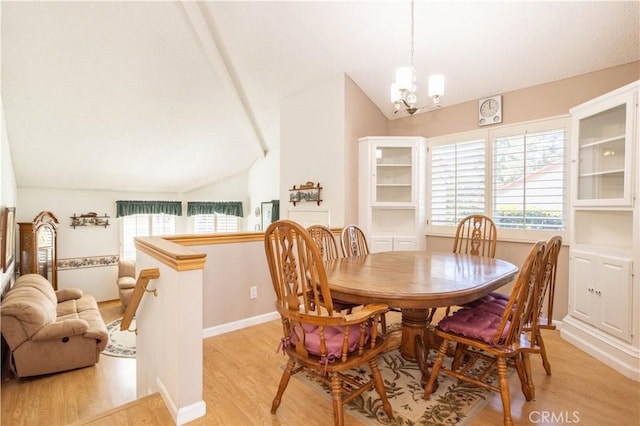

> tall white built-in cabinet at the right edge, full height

[{"left": 561, "top": 82, "right": 640, "bottom": 381}]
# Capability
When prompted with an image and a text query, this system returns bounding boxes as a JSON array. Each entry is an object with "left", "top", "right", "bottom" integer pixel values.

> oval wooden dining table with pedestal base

[{"left": 325, "top": 251, "right": 518, "bottom": 360}]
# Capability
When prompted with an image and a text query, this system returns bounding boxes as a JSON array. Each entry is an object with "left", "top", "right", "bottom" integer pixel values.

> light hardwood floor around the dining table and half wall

[{"left": 1, "top": 302, "right": 640, "bottom": 425}]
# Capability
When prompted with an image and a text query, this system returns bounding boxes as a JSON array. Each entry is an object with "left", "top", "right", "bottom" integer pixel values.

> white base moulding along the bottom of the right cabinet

[{"left": 560, "top": 315, "right": 640, "bottom": 382}]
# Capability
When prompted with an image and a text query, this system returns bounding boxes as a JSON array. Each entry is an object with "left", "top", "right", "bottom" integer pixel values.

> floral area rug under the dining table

[{"left": 293, "top": 349, "right": 497, "bottom": 425}]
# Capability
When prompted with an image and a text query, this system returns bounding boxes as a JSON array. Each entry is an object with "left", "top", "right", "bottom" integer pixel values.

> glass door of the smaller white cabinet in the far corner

[{"left": 373, "top": 145, "right": 413, "bottom": 203}]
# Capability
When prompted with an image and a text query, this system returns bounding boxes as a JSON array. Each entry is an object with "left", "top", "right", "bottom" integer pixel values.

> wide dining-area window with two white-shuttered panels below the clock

[{"left": 427, "top": 118, "right": 570, "bottom": 241}]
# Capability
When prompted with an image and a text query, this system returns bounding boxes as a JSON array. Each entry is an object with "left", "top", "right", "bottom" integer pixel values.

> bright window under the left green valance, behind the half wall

[{"left": 120, "top": 214, "right": 176, "bottom": 260}]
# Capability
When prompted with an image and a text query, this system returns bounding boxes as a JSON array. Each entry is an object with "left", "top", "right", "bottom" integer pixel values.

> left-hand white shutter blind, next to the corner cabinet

[{"left": 430, "top": 139, "right": 485, "bottom": 226}]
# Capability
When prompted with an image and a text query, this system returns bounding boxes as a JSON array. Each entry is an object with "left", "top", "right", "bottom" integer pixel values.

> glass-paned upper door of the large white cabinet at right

[{"left": 574, "top": 90, "right": 634, "bottom": 205}]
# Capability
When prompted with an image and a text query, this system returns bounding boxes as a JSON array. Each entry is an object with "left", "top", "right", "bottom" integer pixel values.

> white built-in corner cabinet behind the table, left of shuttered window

[{"left": 358, "top": 136, "right": 426, "bottom": 253}]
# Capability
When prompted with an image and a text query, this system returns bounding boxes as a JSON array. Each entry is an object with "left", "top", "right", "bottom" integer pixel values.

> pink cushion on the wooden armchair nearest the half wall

[{"left": 291, "top": 324, "right": 371, "bottom": 358}]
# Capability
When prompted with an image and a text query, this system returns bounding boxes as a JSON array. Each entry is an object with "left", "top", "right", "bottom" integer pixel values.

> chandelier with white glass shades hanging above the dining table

[{"left": 391, "top": 0, "right": 444, "bottom": 115}]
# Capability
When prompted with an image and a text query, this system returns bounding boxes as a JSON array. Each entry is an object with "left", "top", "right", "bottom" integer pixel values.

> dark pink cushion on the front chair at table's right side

[{"left": 438, "top": 307, "right": 511, "bottom": 344}]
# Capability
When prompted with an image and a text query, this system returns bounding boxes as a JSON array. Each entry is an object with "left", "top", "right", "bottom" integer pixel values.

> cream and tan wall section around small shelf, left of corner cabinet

[{"left": 279, "top": 74, "right": 387, "bottom": 227}]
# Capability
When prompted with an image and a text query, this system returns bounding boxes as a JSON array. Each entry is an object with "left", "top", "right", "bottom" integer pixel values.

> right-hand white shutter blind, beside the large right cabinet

[{"left": 493, "top": 129, "right": 567, "bottom": 231}]
